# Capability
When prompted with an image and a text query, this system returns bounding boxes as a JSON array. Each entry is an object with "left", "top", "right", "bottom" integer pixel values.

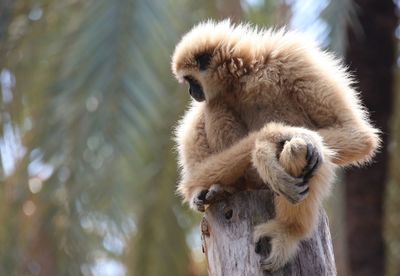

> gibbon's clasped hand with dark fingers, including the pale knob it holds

[{"left": 252, "top": 123, "right": 323, "bottom": 204}]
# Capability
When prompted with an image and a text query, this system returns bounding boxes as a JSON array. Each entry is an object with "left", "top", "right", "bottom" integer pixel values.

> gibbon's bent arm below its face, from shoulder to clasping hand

[{"left": 177, "top": 105, "right": 331, "bottom": 205}]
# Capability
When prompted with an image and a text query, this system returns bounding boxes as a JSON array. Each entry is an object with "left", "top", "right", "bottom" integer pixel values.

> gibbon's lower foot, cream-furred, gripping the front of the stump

[{"left": 254, "top": 220, "right": 298, "bottom": 271}]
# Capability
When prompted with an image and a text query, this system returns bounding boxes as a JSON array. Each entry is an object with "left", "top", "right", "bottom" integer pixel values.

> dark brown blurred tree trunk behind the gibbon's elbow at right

[{"left": 345, "top": 0, "right": 397, "bottom": 276}]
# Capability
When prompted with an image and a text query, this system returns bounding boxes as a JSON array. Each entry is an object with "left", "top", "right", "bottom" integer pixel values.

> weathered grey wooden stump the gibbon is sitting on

[{"left": 201, "top": 190, "right": 336, "bottom": 276}]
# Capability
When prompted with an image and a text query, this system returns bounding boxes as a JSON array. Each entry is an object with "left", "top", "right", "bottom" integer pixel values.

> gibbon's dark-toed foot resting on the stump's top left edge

[{"left": 190, "top": 184, "right": 234, "bottom": 212}]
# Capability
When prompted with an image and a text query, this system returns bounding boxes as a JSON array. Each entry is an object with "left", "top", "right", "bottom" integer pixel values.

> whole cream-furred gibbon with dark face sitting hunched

[{"left": 172, "top": 20, "right": 380, "bottom": 271}]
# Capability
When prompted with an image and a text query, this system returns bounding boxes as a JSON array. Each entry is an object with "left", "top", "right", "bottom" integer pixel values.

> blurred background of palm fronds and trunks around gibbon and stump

[{"left": 0, "top": 0, "right": 400, "bottom": 276}]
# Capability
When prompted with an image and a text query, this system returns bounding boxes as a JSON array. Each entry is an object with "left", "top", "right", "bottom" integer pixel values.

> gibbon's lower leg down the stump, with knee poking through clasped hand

[{"left": 254, "top": 138, "right": 333, "bottom": 271}]
